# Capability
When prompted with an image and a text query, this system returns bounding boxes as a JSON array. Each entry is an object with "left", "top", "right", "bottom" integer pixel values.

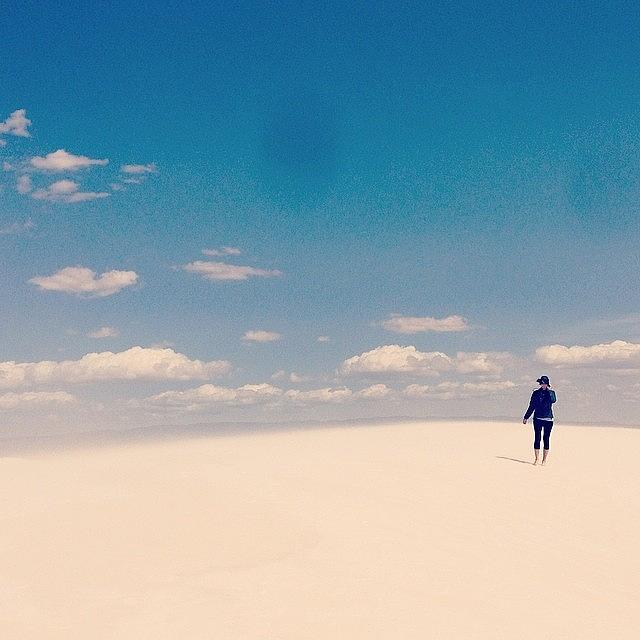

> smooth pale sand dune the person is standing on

[{"left": 0, "top": 422, "right": 640, "bottom": 640}]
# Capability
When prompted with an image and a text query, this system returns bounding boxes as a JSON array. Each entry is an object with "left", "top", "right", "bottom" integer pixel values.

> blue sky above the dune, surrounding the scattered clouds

[{"left": 0, "top": 2, "right": 640, "bottom": 424}]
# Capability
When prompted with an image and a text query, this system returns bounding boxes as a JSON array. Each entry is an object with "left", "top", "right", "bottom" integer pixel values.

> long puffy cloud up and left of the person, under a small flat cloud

[{"left": 339, "top": 344, "right": 509, "bottom": 376}]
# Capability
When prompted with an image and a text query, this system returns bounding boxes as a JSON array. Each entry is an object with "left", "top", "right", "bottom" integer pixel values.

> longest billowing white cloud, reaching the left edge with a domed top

[{"left": 0, "top": 347, "right": 231, "bottom": 389}]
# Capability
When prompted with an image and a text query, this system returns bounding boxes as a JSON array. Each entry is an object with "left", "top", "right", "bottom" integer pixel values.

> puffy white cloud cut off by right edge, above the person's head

[{"left": 536, "top": 340, "right": 640, "bottom": 368}]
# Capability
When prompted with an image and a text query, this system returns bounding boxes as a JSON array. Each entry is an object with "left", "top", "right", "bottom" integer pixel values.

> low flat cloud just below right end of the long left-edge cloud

[{"left": 144, "top": 383, "right": 283, "bottom": 410}]
